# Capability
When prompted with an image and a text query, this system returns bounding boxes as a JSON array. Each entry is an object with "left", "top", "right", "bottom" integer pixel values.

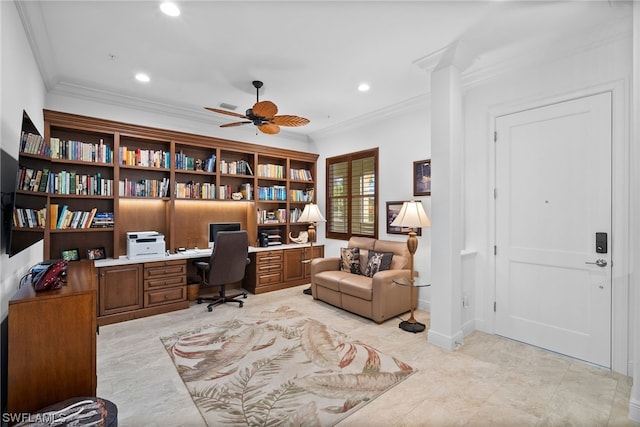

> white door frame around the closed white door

[{"left": 490, "top": 79, "right": 632, "bottom": 375}]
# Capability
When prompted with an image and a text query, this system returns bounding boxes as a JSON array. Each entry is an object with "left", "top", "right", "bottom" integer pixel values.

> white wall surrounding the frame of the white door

[{"left": 464, "top": 38, "right": 632, "bottom": 373}]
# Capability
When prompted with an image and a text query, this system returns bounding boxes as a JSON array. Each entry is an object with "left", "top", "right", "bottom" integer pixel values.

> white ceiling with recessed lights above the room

[{"left": 16, "top": 0, "right": 631, "bottom": 134}]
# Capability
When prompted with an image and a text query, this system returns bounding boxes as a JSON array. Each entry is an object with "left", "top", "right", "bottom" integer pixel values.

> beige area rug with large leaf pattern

[{"left": 160, "top": 306, "right": 413, "bottom": 427}]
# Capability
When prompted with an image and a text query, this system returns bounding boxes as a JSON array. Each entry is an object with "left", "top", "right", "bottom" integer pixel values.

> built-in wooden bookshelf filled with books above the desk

[{"left": 34, "top": 110, "right": 318, "bottom": 258}]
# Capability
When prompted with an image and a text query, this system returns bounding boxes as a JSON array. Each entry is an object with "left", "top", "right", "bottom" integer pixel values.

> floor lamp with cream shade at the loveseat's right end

[{"left": 391, "top": 200, "right": 431, "bottom": 333}]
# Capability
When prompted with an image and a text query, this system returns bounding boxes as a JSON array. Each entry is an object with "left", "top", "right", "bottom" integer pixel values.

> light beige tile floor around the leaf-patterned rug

[{"left": 97, "top": 286, "right": 640, "bottom": 427}]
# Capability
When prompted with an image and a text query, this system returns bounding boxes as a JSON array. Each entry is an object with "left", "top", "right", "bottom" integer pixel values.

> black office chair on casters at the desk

[{"left": 194, "top": 230, "right": 249, "bottom": 311}]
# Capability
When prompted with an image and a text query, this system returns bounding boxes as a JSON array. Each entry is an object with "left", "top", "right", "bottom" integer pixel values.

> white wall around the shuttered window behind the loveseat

[{"left": 313, "top": 98, "right": 431, "bottom": 310}]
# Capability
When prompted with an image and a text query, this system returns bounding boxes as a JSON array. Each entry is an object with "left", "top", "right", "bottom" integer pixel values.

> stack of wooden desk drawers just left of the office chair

[{"left": 144, "top": 260, "right": 187, "bottom": 307}]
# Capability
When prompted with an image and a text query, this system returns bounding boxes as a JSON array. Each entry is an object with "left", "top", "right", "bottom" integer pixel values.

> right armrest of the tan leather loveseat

[{"left": 371, "top": 270, "right": 418, "bottom": 323}]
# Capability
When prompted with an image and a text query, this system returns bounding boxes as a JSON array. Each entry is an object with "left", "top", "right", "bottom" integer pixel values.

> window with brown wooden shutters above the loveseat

[{"left": 325, "top": 148, "right": 378, "bottom": 240}]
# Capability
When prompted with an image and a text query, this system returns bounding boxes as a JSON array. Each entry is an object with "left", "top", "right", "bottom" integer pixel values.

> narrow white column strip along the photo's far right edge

[{"left": 629, "top": 2, "right": 640, "bottom": 421}]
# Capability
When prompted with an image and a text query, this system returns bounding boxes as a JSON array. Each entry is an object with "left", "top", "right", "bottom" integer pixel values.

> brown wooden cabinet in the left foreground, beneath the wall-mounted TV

[{"left": 7, "top": 261, "right": 97, "bottom": 413}]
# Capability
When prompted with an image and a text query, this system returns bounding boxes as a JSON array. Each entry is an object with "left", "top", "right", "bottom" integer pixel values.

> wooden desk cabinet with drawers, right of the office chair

[{"left": 242, "top": 245, "right": 324, "bottom": 294}]
